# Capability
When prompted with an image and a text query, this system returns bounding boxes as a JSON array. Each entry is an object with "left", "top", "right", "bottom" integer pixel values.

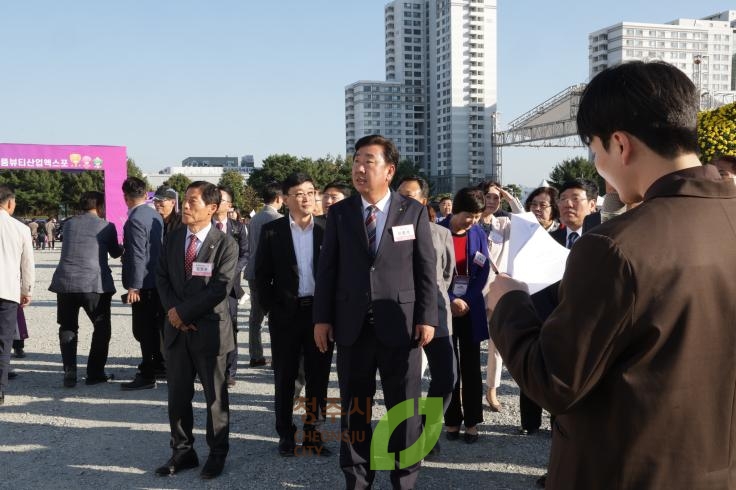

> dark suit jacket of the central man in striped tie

[{"left": 314, "top": 192, "right": 438, "bottom": 346}]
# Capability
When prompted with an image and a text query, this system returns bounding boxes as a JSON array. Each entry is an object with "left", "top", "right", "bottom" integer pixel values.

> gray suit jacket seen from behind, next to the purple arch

[{"left": 49, "top": 213, "right": 123, "bottom": 293}]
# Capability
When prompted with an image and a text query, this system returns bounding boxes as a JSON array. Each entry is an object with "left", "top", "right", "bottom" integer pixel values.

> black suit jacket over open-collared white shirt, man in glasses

[{"left": 255, "top": 216, "right": 325, "bottom": 321}]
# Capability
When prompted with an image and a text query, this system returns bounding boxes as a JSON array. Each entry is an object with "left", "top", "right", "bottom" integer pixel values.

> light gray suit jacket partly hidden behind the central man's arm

[{"left": 429, "top": 223, "right": 455, "bottom": 337}]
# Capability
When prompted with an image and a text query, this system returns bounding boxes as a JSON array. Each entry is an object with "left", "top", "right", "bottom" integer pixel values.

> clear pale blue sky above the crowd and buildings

[{"left": 0, "top": 0, "right": 736, "bottom": 186}]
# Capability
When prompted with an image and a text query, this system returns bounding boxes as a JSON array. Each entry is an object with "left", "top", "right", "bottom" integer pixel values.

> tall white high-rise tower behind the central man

[{"left": 345, "top": 0, "right": 500, "bottom": 192}]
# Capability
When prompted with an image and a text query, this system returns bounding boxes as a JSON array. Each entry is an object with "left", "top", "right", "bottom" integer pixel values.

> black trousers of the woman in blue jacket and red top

[{"left": 445, "top": 315, "right": 483, "bottom": 428}]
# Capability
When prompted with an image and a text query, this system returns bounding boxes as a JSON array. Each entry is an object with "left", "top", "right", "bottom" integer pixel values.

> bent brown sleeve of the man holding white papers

[{"left": 490, "top": 235, "right": 636, "bottom": 414}]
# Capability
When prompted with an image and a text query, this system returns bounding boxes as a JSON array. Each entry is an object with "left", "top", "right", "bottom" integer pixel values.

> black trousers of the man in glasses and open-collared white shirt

[{"left": 269, "top": 303, "right": 332, "bottom": 438}]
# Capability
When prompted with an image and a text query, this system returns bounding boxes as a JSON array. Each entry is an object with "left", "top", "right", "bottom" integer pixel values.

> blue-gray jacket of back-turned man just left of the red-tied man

[{"left": 123, "top": 204, "right": 164, "bottom": 289}]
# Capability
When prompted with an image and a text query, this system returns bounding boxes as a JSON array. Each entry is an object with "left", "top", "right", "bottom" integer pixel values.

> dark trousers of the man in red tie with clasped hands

[{"left": 166, "top": 332, "right": 230, "bottom": 456}]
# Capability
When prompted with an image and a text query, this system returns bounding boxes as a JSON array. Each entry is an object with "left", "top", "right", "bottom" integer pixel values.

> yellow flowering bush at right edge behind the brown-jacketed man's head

[{"left": 698, "top": 102, "right": 736, "bottom": 163}]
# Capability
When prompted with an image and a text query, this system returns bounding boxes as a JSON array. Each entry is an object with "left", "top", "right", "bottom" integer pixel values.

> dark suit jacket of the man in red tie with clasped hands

[{"left": 156, "top": 226, "right": 238, "bottom": 356}]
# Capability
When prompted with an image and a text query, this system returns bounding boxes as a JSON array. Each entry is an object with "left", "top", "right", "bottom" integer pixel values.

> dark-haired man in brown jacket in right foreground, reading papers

[{"left": 490, "top": 62, "right": 736, "bottom": 490}]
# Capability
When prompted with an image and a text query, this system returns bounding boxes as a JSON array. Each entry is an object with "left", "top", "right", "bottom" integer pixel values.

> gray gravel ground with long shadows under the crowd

[{"left": 0, "top": 249, "right": 550, "bottom": 490}]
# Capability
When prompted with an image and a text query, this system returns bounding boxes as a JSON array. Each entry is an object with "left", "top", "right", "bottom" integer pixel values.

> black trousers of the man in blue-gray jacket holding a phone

[{"left": 131, "top": 289, "right": 164, "bottom": 380}]
